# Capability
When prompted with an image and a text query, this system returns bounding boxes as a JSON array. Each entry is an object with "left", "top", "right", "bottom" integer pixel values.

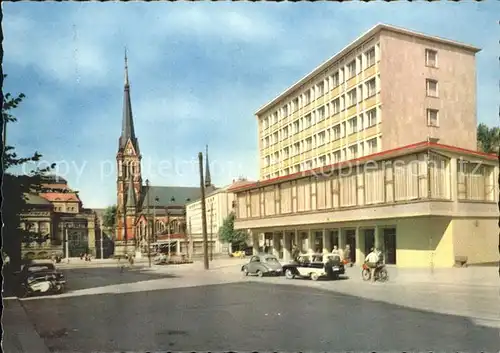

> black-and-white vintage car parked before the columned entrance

[{"left": 283, "top": 254, "right": 345, "bottom": 281}]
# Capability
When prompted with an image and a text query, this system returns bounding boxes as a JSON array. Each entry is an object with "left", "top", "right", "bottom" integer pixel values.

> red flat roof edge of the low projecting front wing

[{"left": 228, "top": 141, "right": 498, "bottom": 193}]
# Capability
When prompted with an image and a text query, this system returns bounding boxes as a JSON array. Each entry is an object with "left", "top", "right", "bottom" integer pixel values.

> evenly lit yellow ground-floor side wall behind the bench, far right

[{"left": 453, "top": 218, "right": 498, "bottom": 264}]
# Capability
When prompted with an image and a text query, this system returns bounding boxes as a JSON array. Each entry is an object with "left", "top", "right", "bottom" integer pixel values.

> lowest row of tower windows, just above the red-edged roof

[{"left": 264, "top": 137, "right": 379, "bottom": 179}]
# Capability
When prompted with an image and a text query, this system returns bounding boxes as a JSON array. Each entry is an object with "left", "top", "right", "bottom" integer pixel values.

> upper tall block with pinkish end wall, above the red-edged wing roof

[{"left": 256, "top": 24, "right": 480, "bottom": 179}]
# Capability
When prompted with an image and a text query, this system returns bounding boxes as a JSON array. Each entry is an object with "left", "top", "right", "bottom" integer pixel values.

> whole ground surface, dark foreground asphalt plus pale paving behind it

[{"left": 4, "top": 260, "right": 500, "bottom": 352}]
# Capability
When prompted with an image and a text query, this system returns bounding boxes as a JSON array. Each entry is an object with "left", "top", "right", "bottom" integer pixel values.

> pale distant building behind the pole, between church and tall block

[{"left": 186, "top": 180, "right": 251, "bottom": 256}]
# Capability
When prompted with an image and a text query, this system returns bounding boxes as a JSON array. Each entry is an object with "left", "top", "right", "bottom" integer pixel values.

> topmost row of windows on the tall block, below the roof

[{"left": 261, "top": 47, "right": 376, "bottom": 130}]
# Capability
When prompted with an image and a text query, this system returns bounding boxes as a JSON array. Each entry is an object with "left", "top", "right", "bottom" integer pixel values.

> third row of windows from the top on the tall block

[{"left": 264, "top": 108, "right": 378, "bottom": 167}]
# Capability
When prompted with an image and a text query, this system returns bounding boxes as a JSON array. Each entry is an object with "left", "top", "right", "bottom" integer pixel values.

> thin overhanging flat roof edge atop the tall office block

[{"left": 255, "top": 23, "right": 481, "bottom": 116}]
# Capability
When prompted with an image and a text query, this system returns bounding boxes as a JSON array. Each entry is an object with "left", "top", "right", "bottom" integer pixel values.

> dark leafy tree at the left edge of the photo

[{"left": 1, "top": 75, "right": 55, "bottom": 270}]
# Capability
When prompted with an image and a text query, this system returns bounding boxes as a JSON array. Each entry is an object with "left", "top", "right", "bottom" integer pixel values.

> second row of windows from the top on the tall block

[{"left": 262, "top": 77, "right": 379, "bottom": 143}]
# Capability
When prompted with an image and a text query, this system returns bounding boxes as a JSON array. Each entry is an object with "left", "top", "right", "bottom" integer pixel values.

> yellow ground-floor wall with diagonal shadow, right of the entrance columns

[{"left": 396, "top": 217, "right": 454, "bottom": 268}]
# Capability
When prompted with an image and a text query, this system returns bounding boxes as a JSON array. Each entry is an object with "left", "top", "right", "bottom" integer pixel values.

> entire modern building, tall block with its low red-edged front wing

[{"left": 229, "top": 25, "right": 499, "bottom": 268}]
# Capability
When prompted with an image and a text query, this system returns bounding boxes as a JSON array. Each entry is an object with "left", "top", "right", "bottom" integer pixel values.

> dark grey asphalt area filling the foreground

[{"left": 23, "top": 279, "right": 500, "bottom": 352}]
